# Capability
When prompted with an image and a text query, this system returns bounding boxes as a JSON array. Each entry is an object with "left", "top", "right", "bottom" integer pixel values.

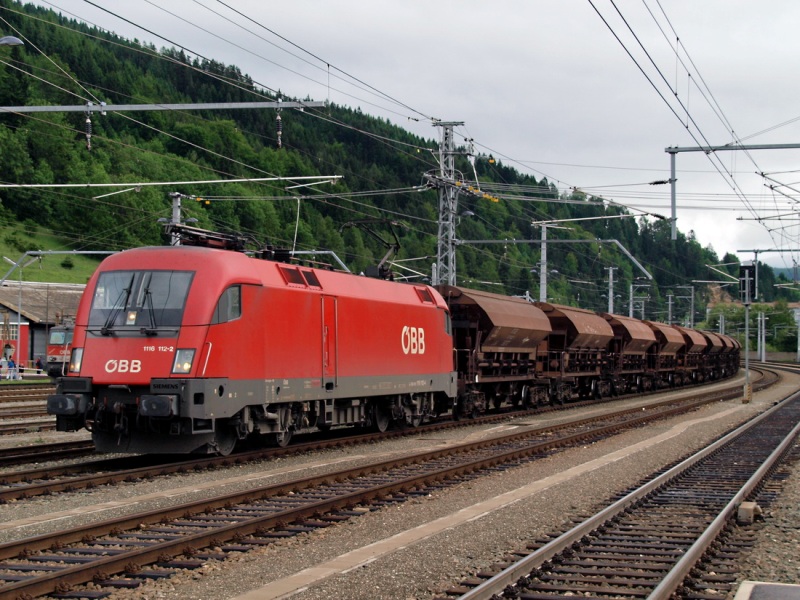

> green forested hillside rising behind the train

[{"left": 0, "top": 0, "right": 792, "bottom": 319}]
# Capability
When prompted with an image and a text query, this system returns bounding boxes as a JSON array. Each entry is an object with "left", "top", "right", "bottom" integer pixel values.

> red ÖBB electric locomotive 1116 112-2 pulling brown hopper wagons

[{"left": 48, "top": 228, "right": 456, "bottom": 454}]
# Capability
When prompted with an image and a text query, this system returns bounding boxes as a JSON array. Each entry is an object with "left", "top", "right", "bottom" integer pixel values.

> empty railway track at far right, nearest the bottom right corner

[{"left": 448, "top": 384, "right": 800, "bottom": 600}]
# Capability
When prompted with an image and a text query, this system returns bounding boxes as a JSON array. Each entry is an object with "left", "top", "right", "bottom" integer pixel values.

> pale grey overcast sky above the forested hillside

[{"left": 18, "top": 0, "right": 800, "bottom": 266}]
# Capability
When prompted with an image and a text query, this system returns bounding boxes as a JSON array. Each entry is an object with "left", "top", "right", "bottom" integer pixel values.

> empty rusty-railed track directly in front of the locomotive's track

[{"left": 0, "top": 370, "right": 780, "bottom": 599}]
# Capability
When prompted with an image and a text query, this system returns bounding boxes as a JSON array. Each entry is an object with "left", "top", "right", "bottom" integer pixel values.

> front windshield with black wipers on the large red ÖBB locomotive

[{"left": 89, "top": 271, "right": 194, "bottom": 335}]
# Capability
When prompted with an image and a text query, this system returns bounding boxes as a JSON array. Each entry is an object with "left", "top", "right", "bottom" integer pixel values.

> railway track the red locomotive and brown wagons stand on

[{"left": 0, "top": 375, "right": 764, "bottom": 503}]
